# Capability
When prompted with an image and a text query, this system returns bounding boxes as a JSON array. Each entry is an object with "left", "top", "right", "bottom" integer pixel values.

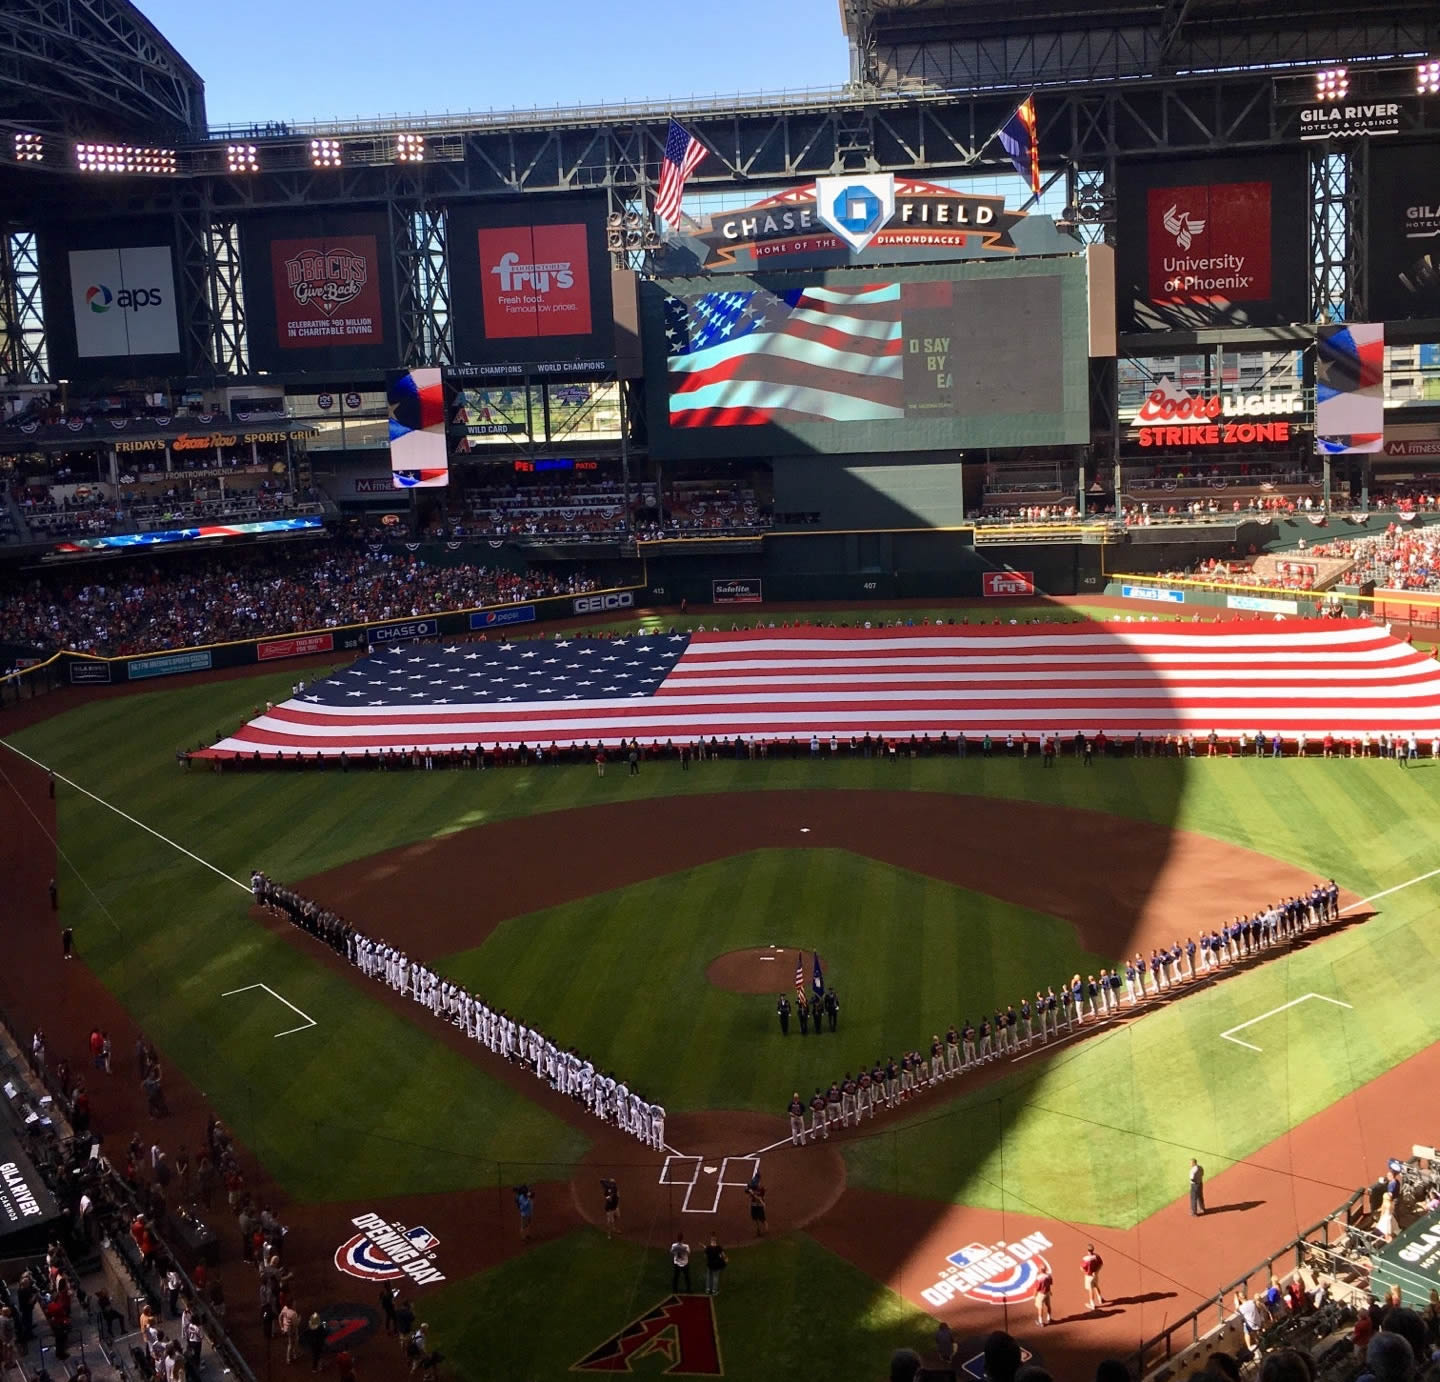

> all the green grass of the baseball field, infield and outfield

[{"left": 8, "top": 610, "right": 1440, "bottom": 1379}]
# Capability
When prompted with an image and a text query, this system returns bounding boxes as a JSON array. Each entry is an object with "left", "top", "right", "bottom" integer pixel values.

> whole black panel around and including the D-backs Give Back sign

[{"left": 240, "top": 209, "right": 397, "bottom": 371}]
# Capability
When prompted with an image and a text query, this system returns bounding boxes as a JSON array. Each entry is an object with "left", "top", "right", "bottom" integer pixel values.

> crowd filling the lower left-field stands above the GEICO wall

[{"left": 0, "top": 544, "right": 596, "bottom": 655}]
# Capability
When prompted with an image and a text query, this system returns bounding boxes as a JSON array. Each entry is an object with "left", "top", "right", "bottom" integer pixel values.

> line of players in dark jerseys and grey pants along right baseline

[{"left": 785, "top": 880, "right": 1341, "bottom": 1146}]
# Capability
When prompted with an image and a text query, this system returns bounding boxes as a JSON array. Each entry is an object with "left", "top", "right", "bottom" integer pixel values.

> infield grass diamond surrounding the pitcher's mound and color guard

[{"left": 439, "top": 849, "right": 1110, "bottom": 1114}]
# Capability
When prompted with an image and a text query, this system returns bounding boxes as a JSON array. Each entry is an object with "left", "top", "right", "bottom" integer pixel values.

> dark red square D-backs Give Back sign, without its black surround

[{"left": 271, "top": 235, "right": 384, "bottom": 348}]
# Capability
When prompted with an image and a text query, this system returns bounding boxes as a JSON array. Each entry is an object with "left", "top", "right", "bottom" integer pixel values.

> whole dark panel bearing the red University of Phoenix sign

[{"left": 1116, "top": 151, "right": 1309, "bottom": 331}]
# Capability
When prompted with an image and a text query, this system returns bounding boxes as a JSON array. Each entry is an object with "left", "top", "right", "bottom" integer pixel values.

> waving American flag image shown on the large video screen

[{"left": 665, "top": 284, "right": 904, "bottom": 428}]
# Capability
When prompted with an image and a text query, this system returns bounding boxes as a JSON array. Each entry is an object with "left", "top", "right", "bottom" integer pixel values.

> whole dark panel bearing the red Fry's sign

[{"left": 448, "top": 197, "right": 615, "bottom": 367}]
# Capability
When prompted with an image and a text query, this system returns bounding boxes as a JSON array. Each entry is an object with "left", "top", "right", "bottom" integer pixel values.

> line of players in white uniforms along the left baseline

[{"left": 251, "top": 871, "right": 665, "bottom": 1150}]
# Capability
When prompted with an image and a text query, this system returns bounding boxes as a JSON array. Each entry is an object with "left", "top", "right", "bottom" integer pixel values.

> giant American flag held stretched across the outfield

[{"left": 200, "top": 620, "right": 1440, "bottom": 754}]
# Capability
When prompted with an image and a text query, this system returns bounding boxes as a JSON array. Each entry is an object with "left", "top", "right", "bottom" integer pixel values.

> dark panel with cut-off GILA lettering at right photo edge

[{"left": 1365, "top": 143, "right": 1440, "bottom": 321}]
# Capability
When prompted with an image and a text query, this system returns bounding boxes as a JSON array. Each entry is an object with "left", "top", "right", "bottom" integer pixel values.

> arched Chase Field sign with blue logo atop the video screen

[{"left": 658, "top": 173, "right": 1080, "bottom": 275}]
